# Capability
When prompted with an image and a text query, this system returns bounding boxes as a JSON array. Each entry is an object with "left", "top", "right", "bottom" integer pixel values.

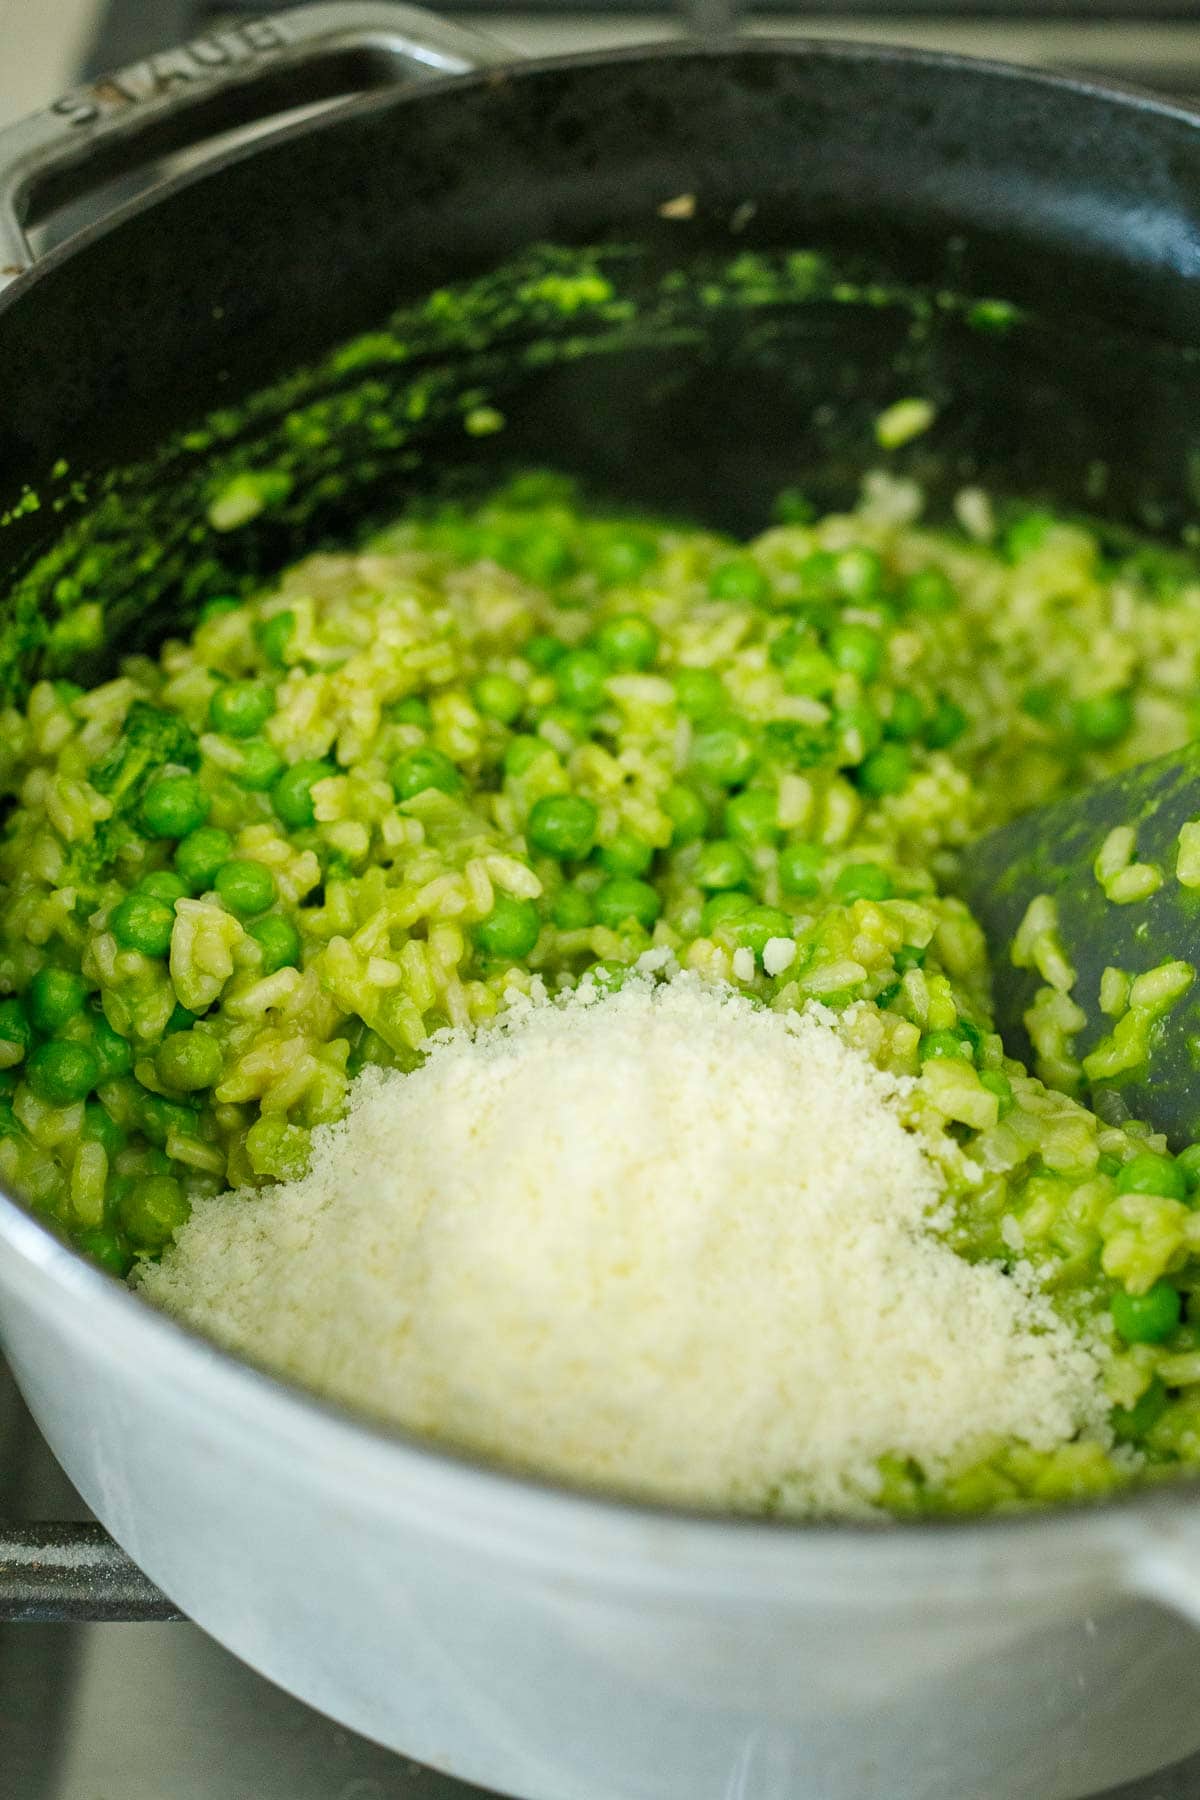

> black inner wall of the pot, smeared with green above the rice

[{"left": 0, "top": 47, "right": 1200, "bottom": 689}]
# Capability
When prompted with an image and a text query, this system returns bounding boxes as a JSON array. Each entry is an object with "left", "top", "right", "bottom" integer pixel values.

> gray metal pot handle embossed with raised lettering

[{"left": 0, "top": 0, "right": 509, "bottom": 292}]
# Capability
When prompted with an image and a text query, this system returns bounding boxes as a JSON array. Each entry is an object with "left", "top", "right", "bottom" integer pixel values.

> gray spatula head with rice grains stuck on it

[{"left": 957, "top": 743, "right": 1200, "bottom": 1150}]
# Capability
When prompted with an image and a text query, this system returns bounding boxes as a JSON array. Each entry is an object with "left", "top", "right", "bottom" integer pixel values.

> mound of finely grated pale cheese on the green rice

[{"left": 142, "top": 976, "right": 1105, "bottom": 1514}]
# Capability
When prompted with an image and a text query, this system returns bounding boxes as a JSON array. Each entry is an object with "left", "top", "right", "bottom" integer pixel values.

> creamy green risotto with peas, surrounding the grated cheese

[{"left": 0, "top": 471, "right": 1200, "bottom": 1512}]
